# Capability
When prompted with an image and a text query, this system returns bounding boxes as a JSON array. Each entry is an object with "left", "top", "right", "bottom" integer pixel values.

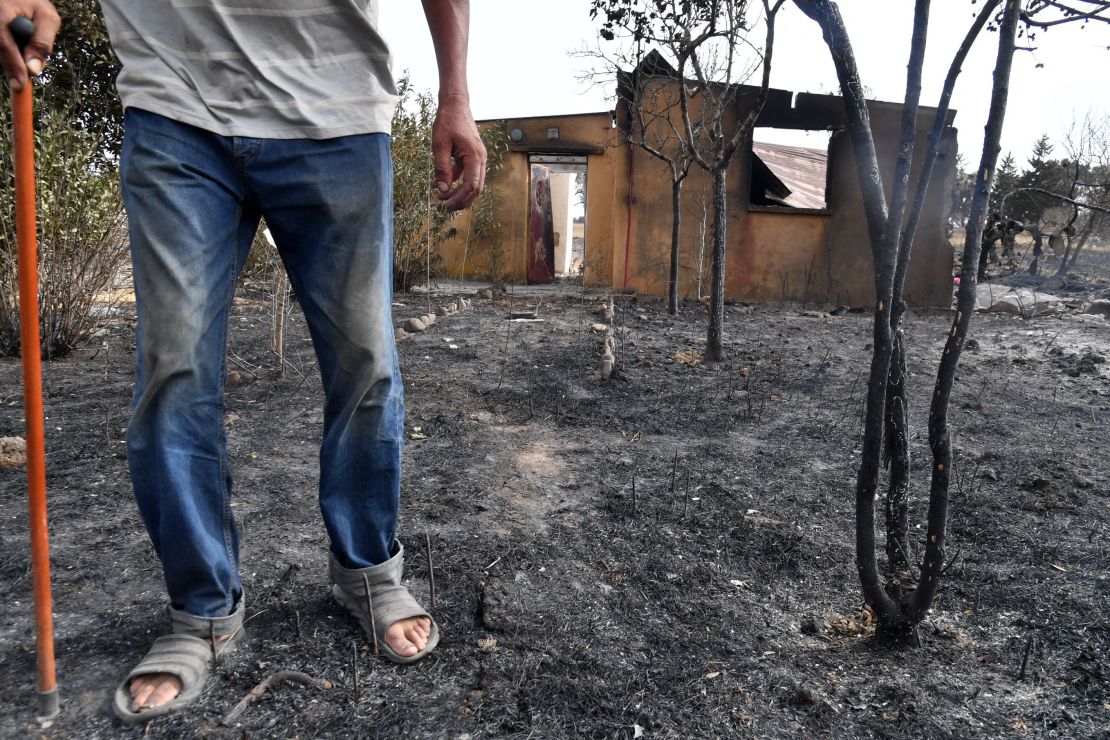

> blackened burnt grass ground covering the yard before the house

[{"left": 0, "top": 284, "right": 1110, "bottom": 739}]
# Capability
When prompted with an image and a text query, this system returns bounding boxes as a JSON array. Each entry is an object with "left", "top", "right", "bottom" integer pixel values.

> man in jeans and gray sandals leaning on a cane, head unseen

[{"left": 0, "top": 0, "right": 485, "bottom": 722}]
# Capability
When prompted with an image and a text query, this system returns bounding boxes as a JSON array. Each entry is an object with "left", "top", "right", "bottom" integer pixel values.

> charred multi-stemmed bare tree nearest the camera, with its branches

[{"left": 795, "top": 0, "right": 1110, "bottom": 642}]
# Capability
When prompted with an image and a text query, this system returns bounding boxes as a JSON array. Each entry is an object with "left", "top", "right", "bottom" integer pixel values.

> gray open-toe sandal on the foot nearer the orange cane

[{"left": 112, "top": 600, "right": 243, "bottom": 724}]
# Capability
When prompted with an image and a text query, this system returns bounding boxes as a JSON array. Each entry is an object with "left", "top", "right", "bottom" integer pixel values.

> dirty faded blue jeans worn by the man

[{"left": 121, "top": 109, "right": 404, "bottom": 617}]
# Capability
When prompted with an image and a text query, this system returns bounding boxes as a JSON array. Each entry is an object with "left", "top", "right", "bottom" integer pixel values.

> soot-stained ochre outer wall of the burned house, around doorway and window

[{"left": 443, "top": 91, "right": 956, "bottom": 306}]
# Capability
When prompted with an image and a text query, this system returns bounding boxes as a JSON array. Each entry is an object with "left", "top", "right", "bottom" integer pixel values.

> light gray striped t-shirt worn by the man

[{"left": 101, "top": 0, "right": 396, "bottom": 139}]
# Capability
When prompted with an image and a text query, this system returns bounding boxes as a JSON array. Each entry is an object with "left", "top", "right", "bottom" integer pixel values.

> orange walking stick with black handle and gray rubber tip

[{"left": 9, "top": 18, "right": 59, "bottom": 718}]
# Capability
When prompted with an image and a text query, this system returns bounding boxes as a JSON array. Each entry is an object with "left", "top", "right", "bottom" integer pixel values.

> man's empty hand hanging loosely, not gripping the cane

[{"left": 432, "top": 98, "right": 486, "bottom": 211}]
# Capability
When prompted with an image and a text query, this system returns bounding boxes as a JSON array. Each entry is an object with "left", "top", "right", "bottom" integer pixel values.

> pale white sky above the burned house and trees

[{"left": 381, "top": 0, "right": 1110, "bottom": 169}]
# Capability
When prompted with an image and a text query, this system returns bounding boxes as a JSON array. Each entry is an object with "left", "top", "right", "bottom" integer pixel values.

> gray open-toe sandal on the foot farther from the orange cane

[{"left": 327, "top": 543, "right": 440, "bottom": 663}]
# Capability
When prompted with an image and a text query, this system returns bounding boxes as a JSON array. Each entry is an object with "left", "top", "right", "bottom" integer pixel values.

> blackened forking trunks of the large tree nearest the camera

[{"left": 795, "top": 0, "right": 1021, "bottom": 643}]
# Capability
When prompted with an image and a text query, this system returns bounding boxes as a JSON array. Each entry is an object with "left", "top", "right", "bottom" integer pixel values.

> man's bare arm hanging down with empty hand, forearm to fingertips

[{"left": 422, "top": 0, "right": 486, "bottom": 211}]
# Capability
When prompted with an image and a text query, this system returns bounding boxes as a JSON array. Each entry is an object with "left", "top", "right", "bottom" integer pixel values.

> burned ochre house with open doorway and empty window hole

[{"left": 441, "top": 56, "right": 956, "bottom": 306}]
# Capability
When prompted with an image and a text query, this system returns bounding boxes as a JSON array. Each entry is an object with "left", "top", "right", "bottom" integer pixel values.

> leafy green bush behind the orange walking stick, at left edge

[{"left": 0, "top": 0, "right": 128, "bottom": 358}]
